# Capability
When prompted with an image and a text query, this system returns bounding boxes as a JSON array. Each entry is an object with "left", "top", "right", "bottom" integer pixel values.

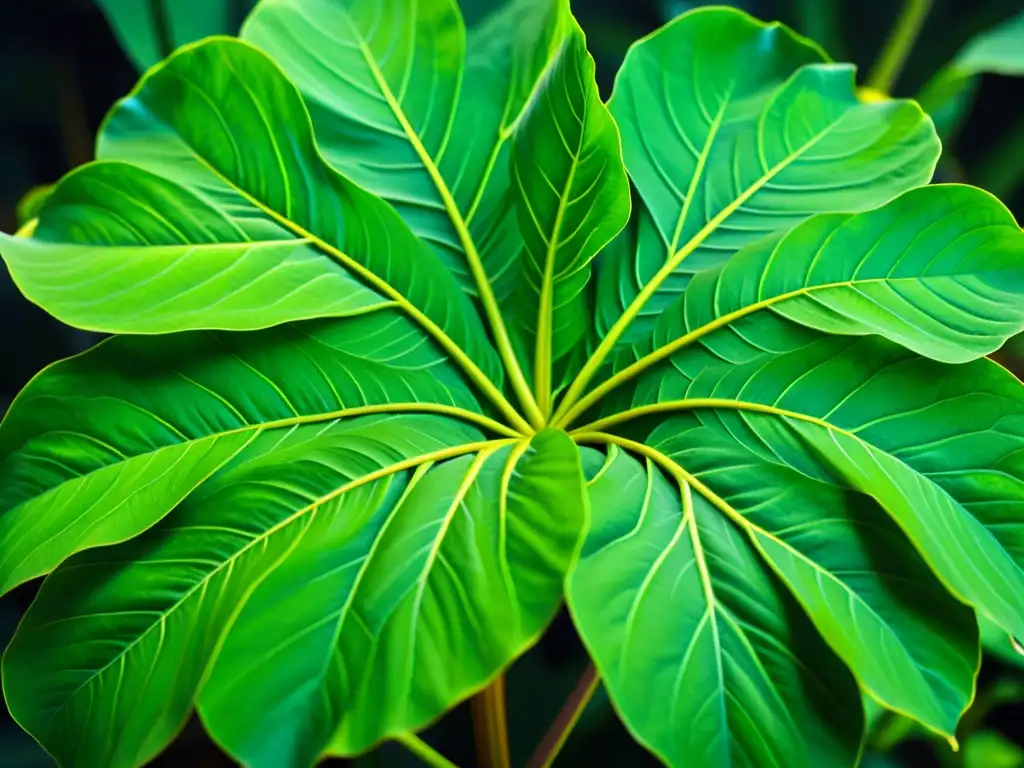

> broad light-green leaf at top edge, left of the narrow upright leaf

[{"left": 242, "top": 0, "right": 569, "bottom": 297}]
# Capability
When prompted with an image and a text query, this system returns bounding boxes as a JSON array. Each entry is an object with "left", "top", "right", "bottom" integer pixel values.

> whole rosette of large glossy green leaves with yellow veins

[{"left": 0, "top": 0, "right": 1024, "bottom": 768}]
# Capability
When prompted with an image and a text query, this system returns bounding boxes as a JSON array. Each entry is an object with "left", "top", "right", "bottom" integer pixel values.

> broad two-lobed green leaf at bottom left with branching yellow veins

[{"left": 4, "top": 416, "right": 585, "bottom": 767}]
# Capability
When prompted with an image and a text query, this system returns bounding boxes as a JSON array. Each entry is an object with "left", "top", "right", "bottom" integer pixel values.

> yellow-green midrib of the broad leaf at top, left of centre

[{"left": 346, "top": 17, "right": 545, "bottom": 429}]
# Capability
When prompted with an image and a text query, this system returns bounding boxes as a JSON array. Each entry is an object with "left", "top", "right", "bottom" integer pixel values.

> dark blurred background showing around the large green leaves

[{"left": 0, "top": 0, "right": 1024, "bottom": 768}]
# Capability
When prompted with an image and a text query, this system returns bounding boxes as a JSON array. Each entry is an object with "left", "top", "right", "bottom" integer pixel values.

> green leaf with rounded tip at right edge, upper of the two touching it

[{"left": 563, "top": 184, "right": 1024, "bottom": 430}]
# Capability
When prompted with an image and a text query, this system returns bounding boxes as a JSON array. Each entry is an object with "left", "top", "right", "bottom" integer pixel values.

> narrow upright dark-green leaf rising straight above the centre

[{"left": 511, "top": 20, "right": 630, "bottom": 414}]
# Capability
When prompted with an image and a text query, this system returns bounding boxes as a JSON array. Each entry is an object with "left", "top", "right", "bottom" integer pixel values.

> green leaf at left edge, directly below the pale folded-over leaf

[{"left": 0, "top": 309, "right": 488, "bottom": 594}]
